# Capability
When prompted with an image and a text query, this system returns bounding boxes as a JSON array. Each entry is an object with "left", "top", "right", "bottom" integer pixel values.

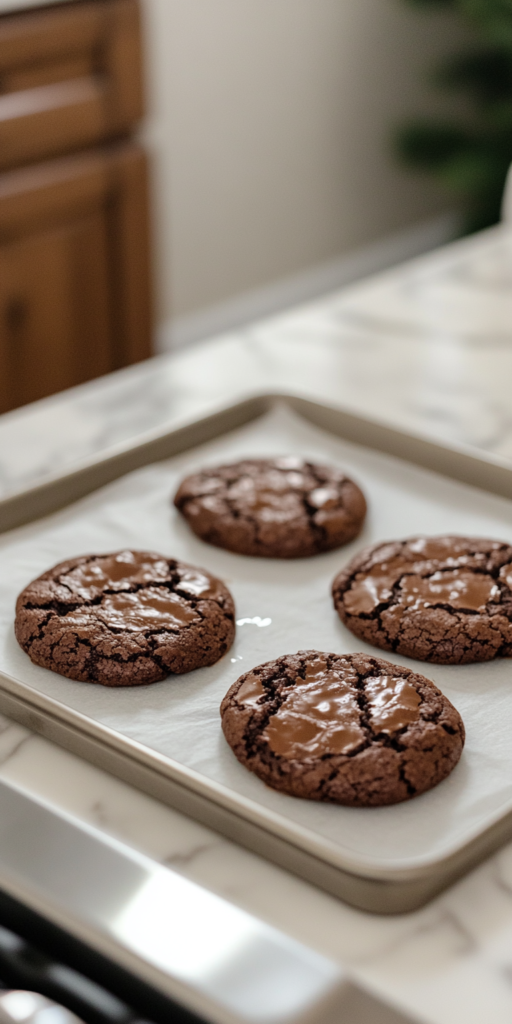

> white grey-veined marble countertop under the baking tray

[{"left": 0, "top": 227, "right": 512, "bottom": 1024}]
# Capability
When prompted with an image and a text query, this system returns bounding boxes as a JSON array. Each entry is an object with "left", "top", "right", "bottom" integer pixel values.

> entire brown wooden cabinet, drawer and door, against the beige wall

[{"left": 0, "top": 0, "right": 151, "bottom": 412}]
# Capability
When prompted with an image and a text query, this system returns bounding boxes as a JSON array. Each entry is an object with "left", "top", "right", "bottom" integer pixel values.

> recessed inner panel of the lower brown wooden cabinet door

[{"left": 0, "top": 212, "right": 112, "bottom": 410}]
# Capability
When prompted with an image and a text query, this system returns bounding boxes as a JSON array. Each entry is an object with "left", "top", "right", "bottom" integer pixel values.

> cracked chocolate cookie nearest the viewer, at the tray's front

[{"left": 220, "top": 650, "right": 464, "bottom": 807}]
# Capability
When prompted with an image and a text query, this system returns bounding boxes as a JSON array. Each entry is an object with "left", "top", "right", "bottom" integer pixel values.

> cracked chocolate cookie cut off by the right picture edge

[{"left": 333, "top": 537, "right": 512, "bottom": 665}]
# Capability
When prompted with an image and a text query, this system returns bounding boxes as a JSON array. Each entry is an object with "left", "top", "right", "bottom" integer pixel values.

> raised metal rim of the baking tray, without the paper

[{"left": 0, "top": 392, "right": 512, "bottom": 912}]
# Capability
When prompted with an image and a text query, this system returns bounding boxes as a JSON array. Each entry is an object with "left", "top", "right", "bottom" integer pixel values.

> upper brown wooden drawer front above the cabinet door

[{"left": 0, "top": 0, "right": 143, "bottom": 168}]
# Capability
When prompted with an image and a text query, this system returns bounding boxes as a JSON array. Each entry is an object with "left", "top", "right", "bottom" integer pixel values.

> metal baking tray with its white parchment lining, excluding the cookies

[{"left": 0, "top": 394, "right": 512, "bottom": 913}]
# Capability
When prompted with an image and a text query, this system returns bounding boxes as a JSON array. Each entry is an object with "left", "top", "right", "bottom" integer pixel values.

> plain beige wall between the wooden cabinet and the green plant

[{"left": 140, "top": 0, "right": 468, "bottom": 321}]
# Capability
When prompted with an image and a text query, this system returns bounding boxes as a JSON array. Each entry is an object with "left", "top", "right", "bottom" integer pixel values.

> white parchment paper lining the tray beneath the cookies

[{"left": 0, "top": 407, "right": 512, "bottom": 873}]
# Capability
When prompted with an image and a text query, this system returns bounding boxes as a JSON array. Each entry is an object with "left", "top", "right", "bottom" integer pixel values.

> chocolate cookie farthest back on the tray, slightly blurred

[{"left": 174, "top": 456, "right": 367, "bottom": 558}]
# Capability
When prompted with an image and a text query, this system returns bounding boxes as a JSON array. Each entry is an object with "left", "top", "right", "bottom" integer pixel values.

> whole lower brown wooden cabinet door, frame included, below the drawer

[{"left": 0, "top": 144, "right": 151, "bottom": 412}]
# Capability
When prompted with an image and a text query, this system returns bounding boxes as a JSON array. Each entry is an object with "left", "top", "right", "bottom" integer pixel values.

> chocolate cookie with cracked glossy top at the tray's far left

[{"left": 14, "top": 551, "right": 234, "bottom": 686}]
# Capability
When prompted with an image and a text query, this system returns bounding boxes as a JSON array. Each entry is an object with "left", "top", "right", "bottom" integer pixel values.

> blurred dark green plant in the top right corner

[{"left": 397, "top": 0, "right": 512, "bottom": 231}]
